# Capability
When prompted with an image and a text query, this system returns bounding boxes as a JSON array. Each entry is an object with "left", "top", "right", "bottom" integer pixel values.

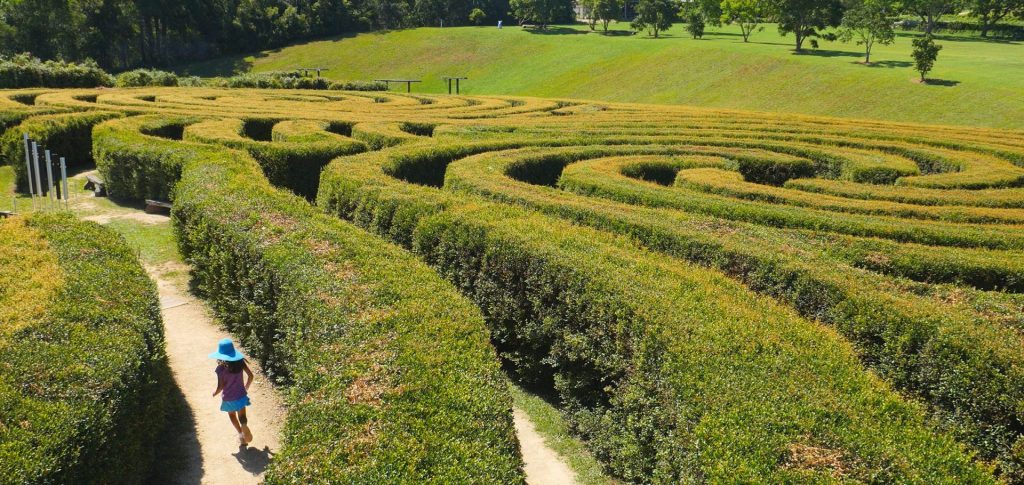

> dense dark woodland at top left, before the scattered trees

[{"left": 0, "top": 0, "right": 516, "bottom": 71}]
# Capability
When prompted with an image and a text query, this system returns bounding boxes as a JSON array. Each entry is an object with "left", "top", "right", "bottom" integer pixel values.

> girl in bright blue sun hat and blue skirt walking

[{"left": 210, "top": 339, "right": 253, "bottom": 445}]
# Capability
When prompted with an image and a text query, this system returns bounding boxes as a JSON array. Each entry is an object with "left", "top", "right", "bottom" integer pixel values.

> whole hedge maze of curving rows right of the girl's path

[{"left": 0, "top": 88, "right": 1024, "bottom": 483}]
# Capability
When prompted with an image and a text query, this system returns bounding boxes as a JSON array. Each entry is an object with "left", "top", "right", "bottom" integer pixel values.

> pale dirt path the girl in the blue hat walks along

[{"left": 76, "top": 199, "right": 285, "bottom": 485}]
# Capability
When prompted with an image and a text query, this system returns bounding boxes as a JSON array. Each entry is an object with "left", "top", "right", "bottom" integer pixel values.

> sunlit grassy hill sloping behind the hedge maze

[{"left": 180, "top": 25, "right": 1024, "bottom": 128}]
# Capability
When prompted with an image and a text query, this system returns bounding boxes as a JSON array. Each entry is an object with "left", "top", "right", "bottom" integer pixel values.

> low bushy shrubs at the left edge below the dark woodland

[{"left": 0, "top": 53, "right": 114, "bottom": 89}]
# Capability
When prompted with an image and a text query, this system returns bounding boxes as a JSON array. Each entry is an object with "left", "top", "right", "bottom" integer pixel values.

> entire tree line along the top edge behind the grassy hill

[{"left": 0, "top": 0, "right": 1024, "bottom": 71}]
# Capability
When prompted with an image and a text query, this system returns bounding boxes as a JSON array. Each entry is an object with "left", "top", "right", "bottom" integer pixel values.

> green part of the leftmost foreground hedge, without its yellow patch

[{"left": 0, "top": 215, "right": 172, "bottom": 483}]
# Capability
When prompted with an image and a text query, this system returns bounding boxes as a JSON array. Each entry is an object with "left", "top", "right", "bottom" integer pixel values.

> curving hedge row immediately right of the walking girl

[{"left": 94, "top": 118, "right": 523, "bottom": 483}]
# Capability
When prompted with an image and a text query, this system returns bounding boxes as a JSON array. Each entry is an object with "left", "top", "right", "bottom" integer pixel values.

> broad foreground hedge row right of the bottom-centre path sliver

[{"left": 318, "top": 147, "right": 991, "bottom": 483}]
